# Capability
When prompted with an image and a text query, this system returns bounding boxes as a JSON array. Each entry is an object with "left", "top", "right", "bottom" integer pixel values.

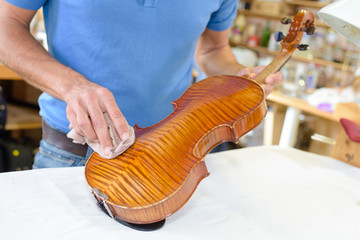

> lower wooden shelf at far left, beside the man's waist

[{"left": 5, "top": 104, "right": 42, "bottom": 130}]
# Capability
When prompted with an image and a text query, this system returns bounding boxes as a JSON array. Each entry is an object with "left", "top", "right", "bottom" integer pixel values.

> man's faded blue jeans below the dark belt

[{"left": 33, "top": 140, "right": 93, "bottom": 169}]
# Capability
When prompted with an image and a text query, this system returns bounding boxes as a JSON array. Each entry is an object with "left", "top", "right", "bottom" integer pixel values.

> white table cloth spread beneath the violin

[{"left": 0, "top": 147, "right": 360, "bottom": 240}]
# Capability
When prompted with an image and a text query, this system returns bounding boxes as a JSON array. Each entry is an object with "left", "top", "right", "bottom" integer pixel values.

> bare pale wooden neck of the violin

[{"left": 253, "top": 50, "right": 291, "bottom": 84}]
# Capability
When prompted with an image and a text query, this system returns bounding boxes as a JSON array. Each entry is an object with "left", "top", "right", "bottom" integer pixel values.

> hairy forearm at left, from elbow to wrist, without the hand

[{"left": 0, "top": 15, "right": 88, "bottom": 100}]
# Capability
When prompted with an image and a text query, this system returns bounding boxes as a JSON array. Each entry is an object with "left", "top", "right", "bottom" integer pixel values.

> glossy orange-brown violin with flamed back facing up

[{"left": 85, "top": 10, "right": 315, "bottom": 224}]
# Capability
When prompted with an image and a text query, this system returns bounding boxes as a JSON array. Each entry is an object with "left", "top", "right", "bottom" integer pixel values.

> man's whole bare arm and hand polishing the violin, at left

[{"left": 0, "top": 0, "right": 129, "bottom": 156}]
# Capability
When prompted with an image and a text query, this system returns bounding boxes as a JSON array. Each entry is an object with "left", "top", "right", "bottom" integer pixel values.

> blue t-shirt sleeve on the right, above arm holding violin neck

[{"left": 207, "top": 0, "right": 239, "bottom": 31}]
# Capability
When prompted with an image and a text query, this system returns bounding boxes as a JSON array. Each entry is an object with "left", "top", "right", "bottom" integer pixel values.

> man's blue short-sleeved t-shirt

[{"left": 6, "top": 0, "right": 238, "bottom": 132}]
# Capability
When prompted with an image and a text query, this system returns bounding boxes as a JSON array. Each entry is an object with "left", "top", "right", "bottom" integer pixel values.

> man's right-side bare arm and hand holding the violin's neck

[{"left": 195, "top": 28, "right": 284, "bottom": 95}]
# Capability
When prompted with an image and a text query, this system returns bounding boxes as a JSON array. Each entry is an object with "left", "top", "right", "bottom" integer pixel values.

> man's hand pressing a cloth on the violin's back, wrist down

[{"left": 65, "top": 82, "right": 129, "bottom": 155}]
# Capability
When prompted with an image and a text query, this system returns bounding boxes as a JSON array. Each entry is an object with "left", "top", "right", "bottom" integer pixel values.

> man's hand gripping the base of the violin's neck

[{"left": 236, "top": 66, "right": 284, "bottom": 96}]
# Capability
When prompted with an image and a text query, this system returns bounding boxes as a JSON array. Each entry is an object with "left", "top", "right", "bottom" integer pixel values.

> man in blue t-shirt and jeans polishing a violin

[{"left": 0, "top": 0, "right": 283, "bottom": 168}]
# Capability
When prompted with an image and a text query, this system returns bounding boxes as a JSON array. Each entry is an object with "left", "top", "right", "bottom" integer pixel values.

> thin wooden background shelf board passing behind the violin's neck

[{"left": 232, "top": 44, "right": 344, "bottom": 70}]
